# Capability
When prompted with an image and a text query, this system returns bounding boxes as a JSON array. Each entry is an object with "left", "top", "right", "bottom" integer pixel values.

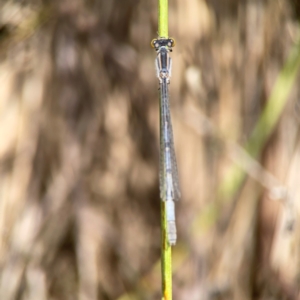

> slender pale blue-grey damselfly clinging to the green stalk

[{"left": 151, "top": 38, "right": 180, "bottom": 245}]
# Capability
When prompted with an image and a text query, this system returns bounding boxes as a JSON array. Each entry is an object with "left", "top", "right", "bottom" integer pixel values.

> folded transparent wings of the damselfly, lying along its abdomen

[{"left": 159, "top": 79, "right": 180, "bottom": 201}]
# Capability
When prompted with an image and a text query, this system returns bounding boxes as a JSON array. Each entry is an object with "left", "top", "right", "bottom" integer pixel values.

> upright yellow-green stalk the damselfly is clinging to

[{"left": 158, "top": 0, "right": 172, "bottom": 300}]
